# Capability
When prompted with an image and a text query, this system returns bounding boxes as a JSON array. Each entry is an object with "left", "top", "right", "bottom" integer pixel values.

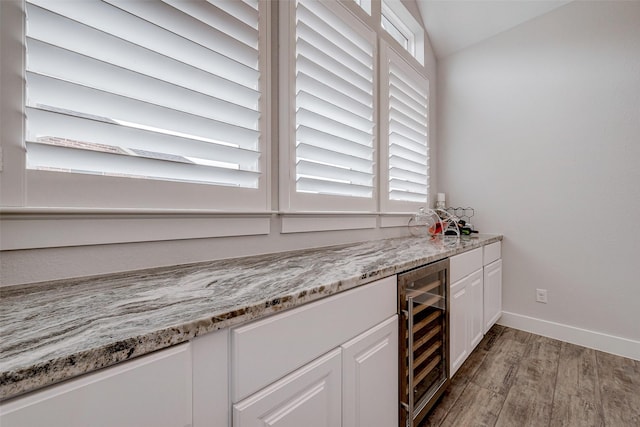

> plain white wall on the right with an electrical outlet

[{"left": 438, "top": 1, "right": 640, "bottom": 352}]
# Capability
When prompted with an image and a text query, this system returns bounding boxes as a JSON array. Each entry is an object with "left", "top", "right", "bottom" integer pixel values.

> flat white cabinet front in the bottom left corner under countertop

[{"left": 0, "top": 344, "right": 192, "bottom": 427}]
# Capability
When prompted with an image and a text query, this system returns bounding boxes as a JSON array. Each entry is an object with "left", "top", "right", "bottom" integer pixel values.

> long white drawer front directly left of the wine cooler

[{"left": 231, "top": 276, "right": 397, "bottom": 402}]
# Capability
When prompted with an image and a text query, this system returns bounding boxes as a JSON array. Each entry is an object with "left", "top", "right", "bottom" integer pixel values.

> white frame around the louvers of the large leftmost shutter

[{"left": 0, "top": 0, "right": 272, "bottom": 212}]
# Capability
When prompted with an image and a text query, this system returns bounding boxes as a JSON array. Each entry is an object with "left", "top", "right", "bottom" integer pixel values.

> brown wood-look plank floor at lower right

[{"left": 420, "top": 325, "right": 640, "bottom": 427}]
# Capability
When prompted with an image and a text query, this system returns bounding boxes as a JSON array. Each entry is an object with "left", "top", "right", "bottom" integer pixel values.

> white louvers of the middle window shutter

[{"left": 295, "top": 0, "right": 375, "bottom": 200}]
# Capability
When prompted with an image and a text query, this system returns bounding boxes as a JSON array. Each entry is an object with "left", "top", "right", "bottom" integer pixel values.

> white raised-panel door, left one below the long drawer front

[{"left": 233, "top": 348, "right": 342, "bottom": 427}]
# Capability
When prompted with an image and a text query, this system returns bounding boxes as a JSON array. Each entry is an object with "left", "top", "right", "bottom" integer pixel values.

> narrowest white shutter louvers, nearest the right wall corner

[{"left": 385, "top": 45, "right": 429, "bottom": 206}]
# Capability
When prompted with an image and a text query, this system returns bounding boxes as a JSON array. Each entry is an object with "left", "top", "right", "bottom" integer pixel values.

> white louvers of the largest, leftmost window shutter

[{"left": 26, "top": 0, "right": 262, "bottom": 188}]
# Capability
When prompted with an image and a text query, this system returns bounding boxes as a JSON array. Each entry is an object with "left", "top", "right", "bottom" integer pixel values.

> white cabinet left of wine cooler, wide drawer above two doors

[{"left": 231, "top": 276, "right": 398, "bottom": 427}]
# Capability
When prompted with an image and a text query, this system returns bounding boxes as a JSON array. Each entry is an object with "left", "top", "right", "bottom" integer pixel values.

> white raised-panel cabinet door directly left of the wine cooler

[{"left": 342, "top": 315, "right": 398, "bottom": 427}]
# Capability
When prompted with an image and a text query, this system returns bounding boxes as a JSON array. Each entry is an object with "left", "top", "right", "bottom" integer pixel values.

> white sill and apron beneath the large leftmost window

[{"left": 0, "top": 208, "right": 273, "bottom": 250}]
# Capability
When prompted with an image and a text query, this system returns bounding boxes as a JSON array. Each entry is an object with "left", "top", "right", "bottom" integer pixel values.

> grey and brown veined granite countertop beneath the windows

[{"left": 0, "top": 235, "right": 502, "bottom": 400}]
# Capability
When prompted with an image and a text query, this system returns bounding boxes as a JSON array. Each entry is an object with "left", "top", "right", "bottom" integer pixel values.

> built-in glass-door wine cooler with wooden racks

[{"left": 398, "top": 259, "right": 449, "bottom": 427}]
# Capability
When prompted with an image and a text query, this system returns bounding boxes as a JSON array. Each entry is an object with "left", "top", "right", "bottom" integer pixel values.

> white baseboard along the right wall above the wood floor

[{"left": 498, "top": 312, "right": 640, "bottom": 360}]
